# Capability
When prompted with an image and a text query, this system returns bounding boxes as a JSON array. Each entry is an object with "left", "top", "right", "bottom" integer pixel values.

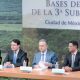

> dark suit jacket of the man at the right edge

[{"left": 64, "top": 52, "right": 80, "bottom": 71}]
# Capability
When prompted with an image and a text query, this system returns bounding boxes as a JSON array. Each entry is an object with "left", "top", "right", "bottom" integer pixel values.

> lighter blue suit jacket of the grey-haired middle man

[{"left": 32, "top": 51, "right": 58, "bottom": 68}]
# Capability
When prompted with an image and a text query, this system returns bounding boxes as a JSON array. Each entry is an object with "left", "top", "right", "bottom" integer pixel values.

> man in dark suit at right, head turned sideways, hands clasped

[{"left": 63, "top": 41, "right": 80, "bottom": 72}]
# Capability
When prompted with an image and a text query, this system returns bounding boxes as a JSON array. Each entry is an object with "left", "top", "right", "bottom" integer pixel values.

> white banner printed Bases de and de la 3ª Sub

[{"left": 22, "top": 0, "right": 80, "bottom": 30}]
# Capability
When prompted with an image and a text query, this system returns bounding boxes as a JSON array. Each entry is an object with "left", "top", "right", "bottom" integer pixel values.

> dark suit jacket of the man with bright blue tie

[{"left": 3, "top": 49, "right": 28, "bottom": 67}]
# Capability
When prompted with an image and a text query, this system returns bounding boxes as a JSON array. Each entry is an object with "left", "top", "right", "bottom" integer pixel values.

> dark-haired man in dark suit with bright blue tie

[{"left": 3, "top": 39, "right": 28, "bottom": 67}]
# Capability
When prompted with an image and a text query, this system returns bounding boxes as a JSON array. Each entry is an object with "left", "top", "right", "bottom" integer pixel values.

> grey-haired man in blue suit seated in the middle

[{"left": 32, "top": 39, "right": 58, "bottom": 68}]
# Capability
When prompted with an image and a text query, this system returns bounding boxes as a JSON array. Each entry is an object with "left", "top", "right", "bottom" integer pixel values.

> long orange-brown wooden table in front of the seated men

[{"left": 0, "top": 67, "right": 80, "bottom": 80}]
